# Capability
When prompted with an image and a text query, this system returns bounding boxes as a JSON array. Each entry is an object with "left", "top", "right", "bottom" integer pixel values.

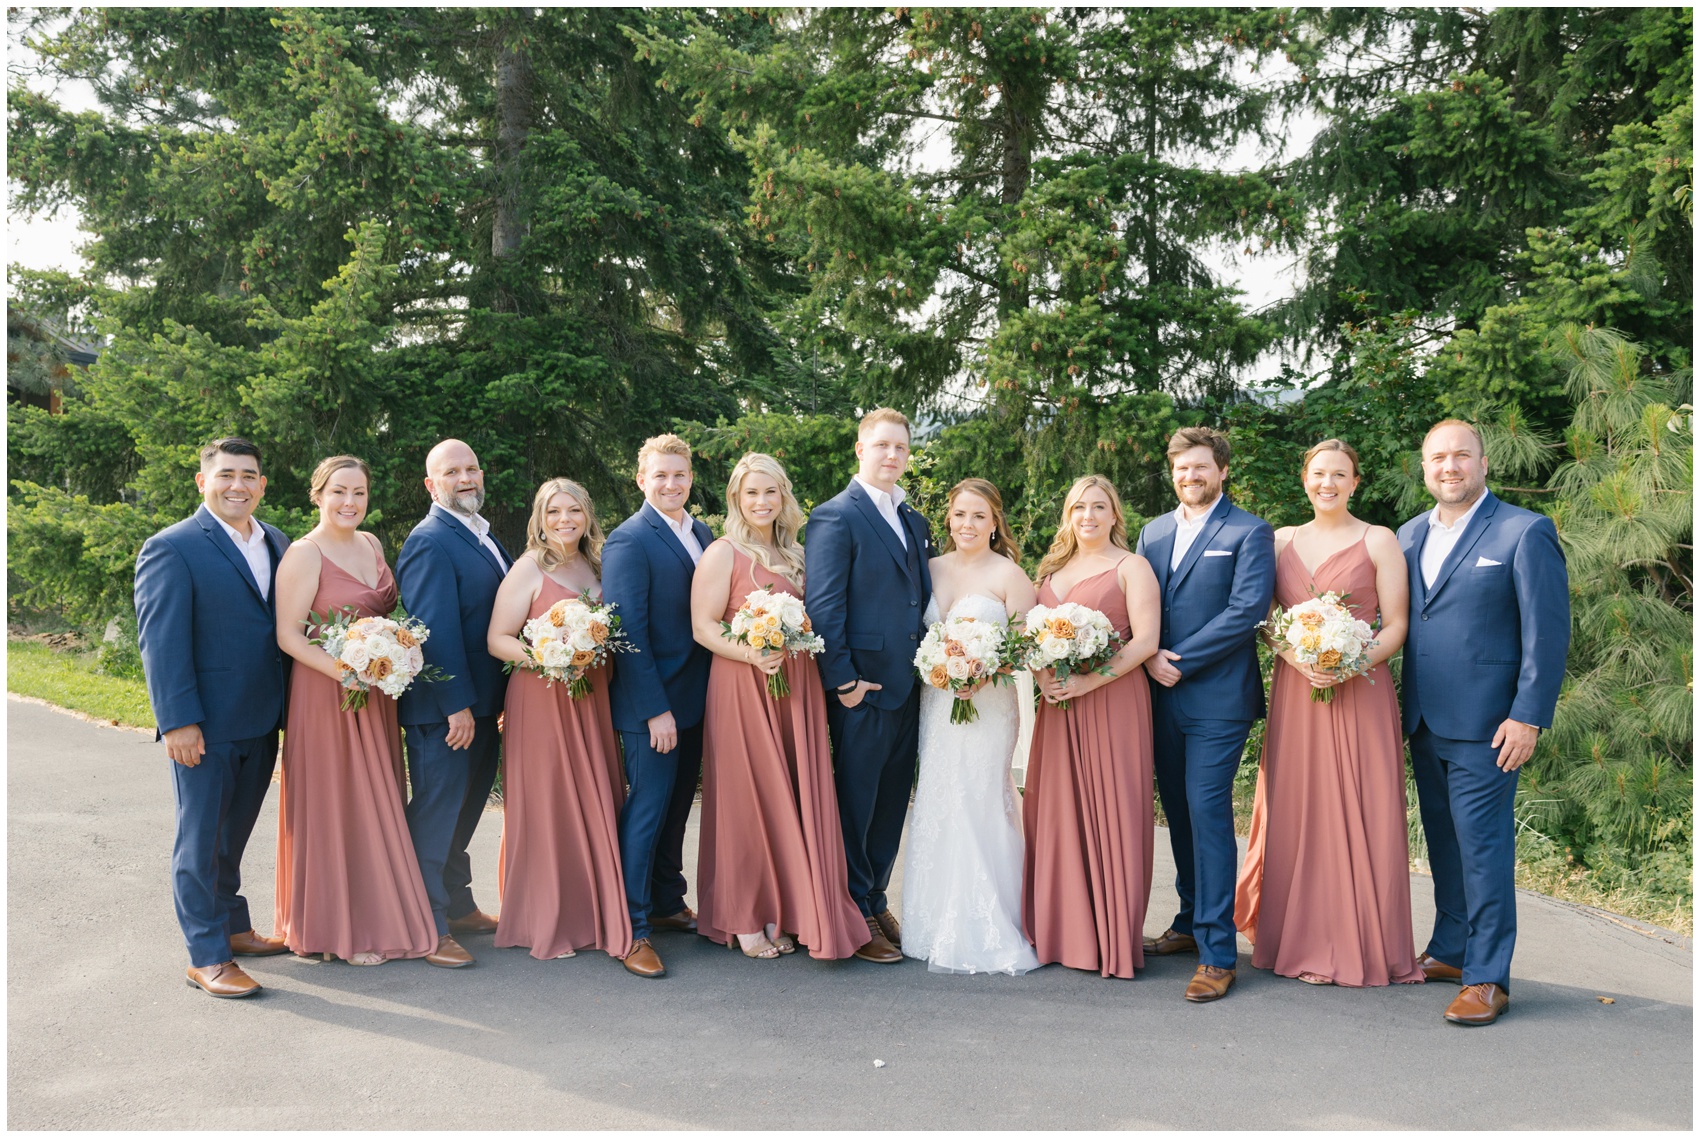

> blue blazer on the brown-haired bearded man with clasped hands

[{"left": 1136, "top": 493, "right": 1275, "bottom": 720}]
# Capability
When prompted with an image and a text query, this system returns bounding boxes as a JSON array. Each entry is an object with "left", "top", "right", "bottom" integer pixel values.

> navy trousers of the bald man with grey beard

[{"left": 403, "top": 714, "right": 502, "bottom": 937}]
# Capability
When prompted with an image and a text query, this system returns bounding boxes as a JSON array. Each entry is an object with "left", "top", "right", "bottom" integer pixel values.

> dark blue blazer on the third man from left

[{"left": 602, "top": 502, "right": 714, "bottom": 731}]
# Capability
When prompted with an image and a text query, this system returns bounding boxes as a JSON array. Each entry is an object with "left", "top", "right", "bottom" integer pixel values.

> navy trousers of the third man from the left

[{"left": 619, "top": 723, "right": 702, "bottom": 941}]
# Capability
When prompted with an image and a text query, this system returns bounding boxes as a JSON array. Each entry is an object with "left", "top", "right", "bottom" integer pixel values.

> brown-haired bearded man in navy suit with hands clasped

[{"left": 1137, "top": 427, "right": 1275, "bottom": 1004}]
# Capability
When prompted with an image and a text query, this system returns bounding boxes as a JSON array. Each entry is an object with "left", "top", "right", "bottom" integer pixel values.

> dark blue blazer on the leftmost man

[{"left": 136, "top": 505, "right": 289, "bottom": 743}]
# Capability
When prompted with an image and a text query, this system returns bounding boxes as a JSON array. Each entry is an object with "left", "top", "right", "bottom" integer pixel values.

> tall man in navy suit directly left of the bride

[{"left": 804, "top": 407, "right": 933, "bottom": 964}]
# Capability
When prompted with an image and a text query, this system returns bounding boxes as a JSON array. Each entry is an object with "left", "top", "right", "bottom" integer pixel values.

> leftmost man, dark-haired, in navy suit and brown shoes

[{"left": 136, "top": 439, "right": 289, "bottom": 999}]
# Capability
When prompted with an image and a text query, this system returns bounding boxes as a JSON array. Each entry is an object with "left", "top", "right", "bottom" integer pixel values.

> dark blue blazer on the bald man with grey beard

[{"left": 396, "top": 505, "right": 513, "bottom": 725}]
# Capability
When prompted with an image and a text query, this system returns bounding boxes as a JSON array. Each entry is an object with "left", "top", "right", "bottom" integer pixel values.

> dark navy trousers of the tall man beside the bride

[{"left": 826, "top": 687, "right": 921, "bottom": 917}]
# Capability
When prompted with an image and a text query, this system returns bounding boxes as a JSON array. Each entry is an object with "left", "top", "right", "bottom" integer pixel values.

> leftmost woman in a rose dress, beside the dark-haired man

[{"left": 277, "top": 454, "right": 438, "bottom": 966}]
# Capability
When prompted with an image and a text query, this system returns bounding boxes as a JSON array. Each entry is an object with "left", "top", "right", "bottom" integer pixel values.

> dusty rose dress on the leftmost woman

[{"left": 277, "top": 540, "right": 437, "bottom": 959}]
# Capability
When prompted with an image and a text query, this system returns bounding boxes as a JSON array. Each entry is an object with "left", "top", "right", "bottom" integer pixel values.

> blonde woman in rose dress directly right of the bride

[{"left": 1022, "top": 475, "right": 1159, "bottom": 980}]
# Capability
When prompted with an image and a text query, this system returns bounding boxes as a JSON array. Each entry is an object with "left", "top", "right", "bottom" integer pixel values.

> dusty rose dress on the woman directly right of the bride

[{"left": 1022, "top": 557, "right": 1153, "bottom": 980}]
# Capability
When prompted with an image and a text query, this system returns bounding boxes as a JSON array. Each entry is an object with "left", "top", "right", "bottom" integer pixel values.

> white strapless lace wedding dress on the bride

[{"left": 903, "top": 594, "right": 1039, "bottom": 976}]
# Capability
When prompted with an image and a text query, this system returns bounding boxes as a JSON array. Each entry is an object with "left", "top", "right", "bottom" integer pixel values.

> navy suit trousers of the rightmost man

[{"left": 1411, "top": 723, "right": 1518, "bottom": 992}]
